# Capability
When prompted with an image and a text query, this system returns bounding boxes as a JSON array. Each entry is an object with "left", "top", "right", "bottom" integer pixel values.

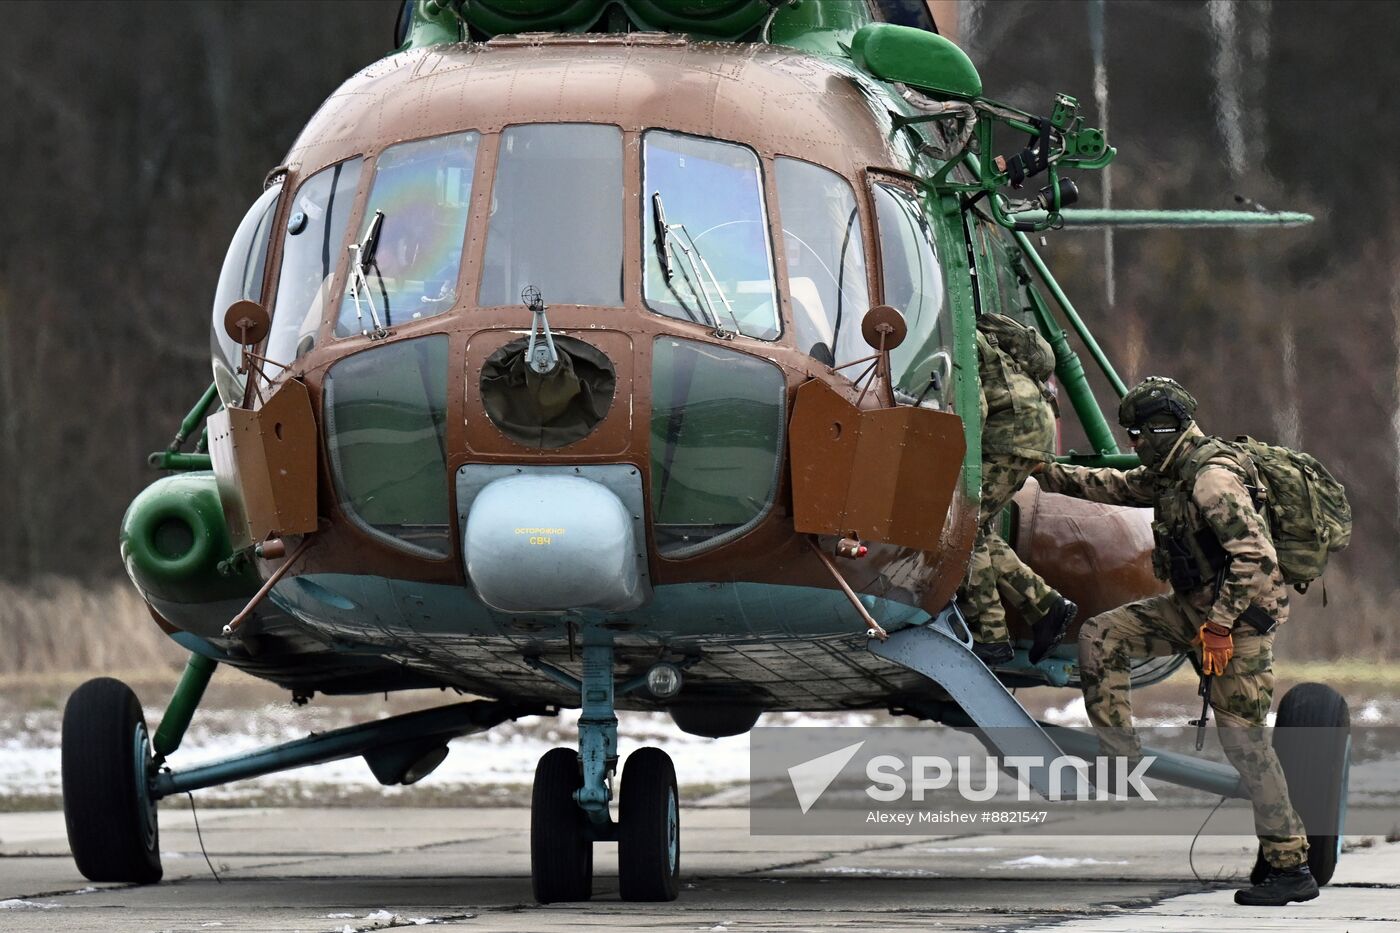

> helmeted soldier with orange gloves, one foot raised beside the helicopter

[{"left": 1040, "top": 377, "right": 1317, "bottom": 905}]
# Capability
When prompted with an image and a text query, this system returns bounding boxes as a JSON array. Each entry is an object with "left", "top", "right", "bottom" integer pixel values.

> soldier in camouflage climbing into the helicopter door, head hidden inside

[{"left": 960, "top": 314, "right": 1077, "bottom": 665}]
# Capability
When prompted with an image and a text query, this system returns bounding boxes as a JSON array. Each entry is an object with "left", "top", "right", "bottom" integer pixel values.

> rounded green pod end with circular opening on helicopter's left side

[{"left": 122, "top": 472, "right": 262, "bottom": 605}]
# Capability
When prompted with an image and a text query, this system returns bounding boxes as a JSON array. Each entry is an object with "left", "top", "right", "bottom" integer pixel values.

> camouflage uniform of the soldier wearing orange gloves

[{"left": 1039, "top": 424, "right": 1308, "bottom": 869}]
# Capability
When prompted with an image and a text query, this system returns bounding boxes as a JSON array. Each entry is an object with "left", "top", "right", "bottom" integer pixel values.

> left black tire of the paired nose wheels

[{"left": 529, "top": 748, "right": 594, "bottom": 904}]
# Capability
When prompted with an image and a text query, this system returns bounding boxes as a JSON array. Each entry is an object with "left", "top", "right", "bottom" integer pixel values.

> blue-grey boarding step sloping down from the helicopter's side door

[{"left": 869, "top": 604, "right": 1081, "bottom": 797}]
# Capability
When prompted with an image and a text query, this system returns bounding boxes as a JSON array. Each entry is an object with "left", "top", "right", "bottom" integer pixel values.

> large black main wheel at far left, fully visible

[{"left": 63, "top": 677, "right": 162, "bottom": 884}]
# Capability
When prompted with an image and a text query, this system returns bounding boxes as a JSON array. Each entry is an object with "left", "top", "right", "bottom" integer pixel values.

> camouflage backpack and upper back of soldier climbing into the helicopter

[{"left": 977, "top": 314, "right": 1058, "bottom": 461}]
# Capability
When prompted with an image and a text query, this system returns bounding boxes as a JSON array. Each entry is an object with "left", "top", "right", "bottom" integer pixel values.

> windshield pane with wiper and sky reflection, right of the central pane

[{"left": 641, "top": 130, "right": 781, "bottom": 340}]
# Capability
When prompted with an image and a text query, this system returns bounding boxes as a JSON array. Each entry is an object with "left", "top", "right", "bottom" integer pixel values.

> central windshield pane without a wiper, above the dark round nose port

[{"left": 479, "top": 123, "right": 623, "bottom": 308}]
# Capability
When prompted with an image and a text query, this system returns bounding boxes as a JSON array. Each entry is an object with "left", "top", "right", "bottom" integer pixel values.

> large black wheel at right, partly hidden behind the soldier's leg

[{"left": 1249, "top": 684, "right": 1351, "bottom": 884}]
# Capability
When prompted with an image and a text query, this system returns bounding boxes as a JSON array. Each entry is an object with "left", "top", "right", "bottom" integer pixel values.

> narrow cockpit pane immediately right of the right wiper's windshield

[{"left": 774, "top": 158, "right": 871, "bottom": 366}]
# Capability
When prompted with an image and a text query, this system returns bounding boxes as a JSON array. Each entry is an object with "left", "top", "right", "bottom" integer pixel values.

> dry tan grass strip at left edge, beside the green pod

[{"left": 0, "top": 577, "right": 185, "bottom": 674}]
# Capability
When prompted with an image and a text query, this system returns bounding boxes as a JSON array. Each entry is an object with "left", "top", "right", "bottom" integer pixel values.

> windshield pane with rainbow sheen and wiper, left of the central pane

[{"left": 335, "top": 132, "right": 480, "bottom": 336}]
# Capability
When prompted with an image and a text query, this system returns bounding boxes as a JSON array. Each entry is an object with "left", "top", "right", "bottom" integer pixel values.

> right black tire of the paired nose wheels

[{"left": 617, "top": 748, "right": 680, "bottom": 901}]
